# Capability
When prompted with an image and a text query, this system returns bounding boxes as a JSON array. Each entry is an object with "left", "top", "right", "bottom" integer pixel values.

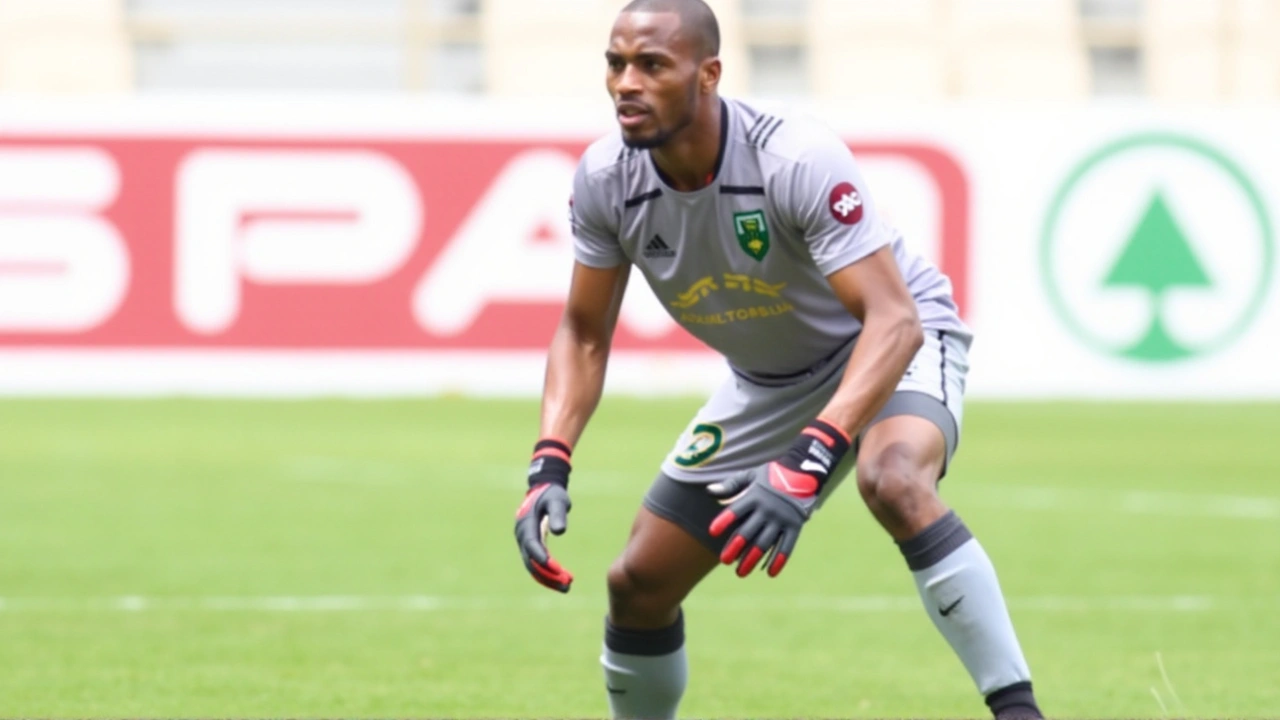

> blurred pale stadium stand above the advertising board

[{"left": 0, "top": 0, "right": 1280, "bottom": 104}]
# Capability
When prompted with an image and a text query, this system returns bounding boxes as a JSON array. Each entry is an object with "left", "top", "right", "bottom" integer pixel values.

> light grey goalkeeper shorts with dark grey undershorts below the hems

[{"left": 644, "top": 329, "right": 970, "bottom": 553}]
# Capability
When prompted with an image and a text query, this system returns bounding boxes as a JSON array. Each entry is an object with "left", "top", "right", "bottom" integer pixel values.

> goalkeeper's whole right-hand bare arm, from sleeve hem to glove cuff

[{"left": 822, "top": 247, "right": 924, "bottom": 437}]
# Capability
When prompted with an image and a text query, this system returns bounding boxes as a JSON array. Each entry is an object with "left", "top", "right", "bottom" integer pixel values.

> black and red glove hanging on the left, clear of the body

[{"left": 516, "top": 439, "right": 573, "bottom": 592}]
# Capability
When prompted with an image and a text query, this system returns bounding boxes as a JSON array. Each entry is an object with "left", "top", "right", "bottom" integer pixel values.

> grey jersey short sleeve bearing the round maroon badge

[{"left": 783, "top": 128, "right": 892, "bottom": 275}]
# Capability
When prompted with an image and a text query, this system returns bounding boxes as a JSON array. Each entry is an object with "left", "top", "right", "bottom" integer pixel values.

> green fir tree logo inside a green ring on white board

[{"left": 1039, "top": 135, "right": 1275, "bottom": 363}]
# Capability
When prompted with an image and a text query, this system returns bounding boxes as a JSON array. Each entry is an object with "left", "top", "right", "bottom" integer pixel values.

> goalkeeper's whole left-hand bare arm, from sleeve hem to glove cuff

[{"left": 540, "top": 263, "right": 631, "bottom": 447}]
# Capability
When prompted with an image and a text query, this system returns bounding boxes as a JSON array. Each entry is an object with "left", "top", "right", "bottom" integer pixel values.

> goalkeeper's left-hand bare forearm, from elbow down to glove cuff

[{"left": 540, "top": 320, "right": 609, "bottom": 447}]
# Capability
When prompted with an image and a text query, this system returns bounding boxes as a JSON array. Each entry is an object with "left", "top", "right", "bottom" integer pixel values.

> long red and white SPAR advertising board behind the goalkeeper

[{"left": 0, "top": 99, "right": 1280, "bottom": 397}]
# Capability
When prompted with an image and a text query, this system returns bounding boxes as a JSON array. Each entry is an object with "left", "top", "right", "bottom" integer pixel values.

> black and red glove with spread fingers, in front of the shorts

[{"left": 707, "top": 420, "right": 851, "bottom": 578}]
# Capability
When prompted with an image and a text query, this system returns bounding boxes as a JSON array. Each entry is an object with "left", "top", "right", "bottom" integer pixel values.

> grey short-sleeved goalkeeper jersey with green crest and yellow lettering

[{"left": 571, "top": 100, "right": 969, "bottom": 378}]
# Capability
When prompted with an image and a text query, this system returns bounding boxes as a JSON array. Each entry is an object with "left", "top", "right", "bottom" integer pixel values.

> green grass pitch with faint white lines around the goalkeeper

[{"left": 0, "top": 398, "right": 1280, "bottom": 717}]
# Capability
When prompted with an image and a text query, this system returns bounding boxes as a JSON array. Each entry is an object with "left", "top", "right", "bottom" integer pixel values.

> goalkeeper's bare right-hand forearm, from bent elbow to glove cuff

[{"left": 819, "top": 309, "right": 924, "bottom": 437}]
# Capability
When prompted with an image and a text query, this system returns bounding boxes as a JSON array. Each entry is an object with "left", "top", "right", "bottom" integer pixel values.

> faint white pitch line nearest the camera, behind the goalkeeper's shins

[{"left": 0, "top": 593, "right": 1259, "bottom": 614}]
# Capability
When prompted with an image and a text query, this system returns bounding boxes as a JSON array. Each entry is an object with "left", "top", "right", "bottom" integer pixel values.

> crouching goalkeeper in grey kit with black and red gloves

[{"left": 516, "top": 0, "right": 1041, "bottom": 720}]
